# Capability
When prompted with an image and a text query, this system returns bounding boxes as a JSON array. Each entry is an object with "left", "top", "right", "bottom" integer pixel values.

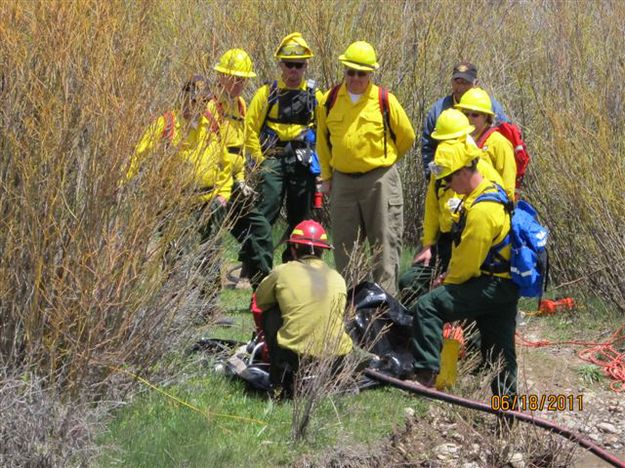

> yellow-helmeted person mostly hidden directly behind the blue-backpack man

[{"left": 399, "top": 109, "right": 503, "bottom": 307}]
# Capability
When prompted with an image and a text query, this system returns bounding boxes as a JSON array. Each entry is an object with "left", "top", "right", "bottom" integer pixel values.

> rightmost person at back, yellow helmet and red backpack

[{"left": 454, "top": 88, "right": 516, "bottom": 200}]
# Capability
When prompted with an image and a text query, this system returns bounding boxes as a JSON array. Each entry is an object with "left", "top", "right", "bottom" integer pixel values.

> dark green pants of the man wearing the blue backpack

[{"left": 411, "top": 275, "right": 519, "bottom": 395}]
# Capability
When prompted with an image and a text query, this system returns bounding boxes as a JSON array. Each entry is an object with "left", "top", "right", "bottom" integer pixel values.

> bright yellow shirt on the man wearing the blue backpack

[{"left": 444, "top": 179, "right": 510, "bottom": 284}]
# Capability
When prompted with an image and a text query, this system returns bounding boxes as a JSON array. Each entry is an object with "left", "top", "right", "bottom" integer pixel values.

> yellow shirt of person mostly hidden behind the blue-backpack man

[{"left": 421, "top": 159, "right": 503, "bottom": 247}]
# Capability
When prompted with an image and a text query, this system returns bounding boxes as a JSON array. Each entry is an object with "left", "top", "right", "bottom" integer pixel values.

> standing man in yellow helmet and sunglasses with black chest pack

[{"left": 244, "top": 32, "right": 322, "bottom": 276}]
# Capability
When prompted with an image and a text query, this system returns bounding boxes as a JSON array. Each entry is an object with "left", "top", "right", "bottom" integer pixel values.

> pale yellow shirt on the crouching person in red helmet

[{"left": 256, "top": 257, "right": 352, "bottom": 357}]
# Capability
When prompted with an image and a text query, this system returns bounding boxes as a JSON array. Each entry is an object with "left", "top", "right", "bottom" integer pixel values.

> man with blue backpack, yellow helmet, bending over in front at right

[{"left": 411, "top": 140, "right": 519, "bottom": 395}]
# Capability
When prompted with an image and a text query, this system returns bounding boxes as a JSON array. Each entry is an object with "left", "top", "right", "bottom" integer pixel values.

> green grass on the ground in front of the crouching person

[{"left": 98, "top": 226, "right": 425, "bottom": 467}]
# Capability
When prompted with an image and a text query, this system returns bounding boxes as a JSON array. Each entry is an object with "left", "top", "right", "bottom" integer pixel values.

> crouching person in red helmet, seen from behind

[{"left": 256, "top": 221, "right": 352, "bottom": 396}]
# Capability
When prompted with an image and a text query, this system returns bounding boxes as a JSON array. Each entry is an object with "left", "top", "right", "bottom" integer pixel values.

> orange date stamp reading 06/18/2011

[{"left": 490, "top": 393, "right": 584, "bottom": 411}]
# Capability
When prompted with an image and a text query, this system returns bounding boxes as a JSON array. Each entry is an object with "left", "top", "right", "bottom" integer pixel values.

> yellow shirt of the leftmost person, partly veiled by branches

[{"left": 126, "top": 111, "right": 232, "bottom": 202}]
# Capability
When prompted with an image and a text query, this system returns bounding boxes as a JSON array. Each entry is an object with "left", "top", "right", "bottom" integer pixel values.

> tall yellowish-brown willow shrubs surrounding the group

[{"left": 0, "top": 0, "right": 625, "bottom": 394}]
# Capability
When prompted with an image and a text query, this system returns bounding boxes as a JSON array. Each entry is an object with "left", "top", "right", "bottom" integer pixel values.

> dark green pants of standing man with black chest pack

[{"left": 251, "top": 151, "right": 315, "bottom": 262}]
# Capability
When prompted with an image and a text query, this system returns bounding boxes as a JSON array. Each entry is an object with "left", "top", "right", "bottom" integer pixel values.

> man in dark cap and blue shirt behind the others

[{"left": 421, "top": 62, "right": 508, "bottom": 178}]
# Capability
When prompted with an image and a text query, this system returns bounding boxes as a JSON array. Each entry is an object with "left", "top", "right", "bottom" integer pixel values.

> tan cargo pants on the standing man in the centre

[{"left": 330, "top": 166, "right": 404, "bottom": 294}]
